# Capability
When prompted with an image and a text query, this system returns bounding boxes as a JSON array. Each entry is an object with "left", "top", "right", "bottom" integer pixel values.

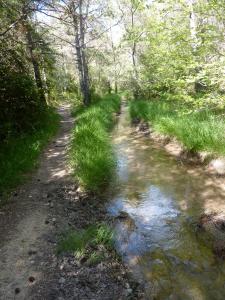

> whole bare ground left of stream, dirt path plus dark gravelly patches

[{"left": 0, "top": 106, "right": 142, "bottom": 300}]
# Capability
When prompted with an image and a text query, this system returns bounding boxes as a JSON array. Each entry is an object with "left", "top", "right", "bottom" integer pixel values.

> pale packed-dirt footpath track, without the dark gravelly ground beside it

[{"left": 0, "top": 106, "right": 73, "bottom": 299}]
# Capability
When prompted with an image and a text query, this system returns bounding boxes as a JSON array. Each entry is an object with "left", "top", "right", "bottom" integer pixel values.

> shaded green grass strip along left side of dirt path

[{"left": 0, "top": 109, "right": 59, "bottom": 193}]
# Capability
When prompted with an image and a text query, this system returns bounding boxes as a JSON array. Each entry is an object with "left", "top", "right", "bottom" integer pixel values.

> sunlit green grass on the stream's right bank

[{"left": 129, "top": 100, "right": 225, "bottom": 155}]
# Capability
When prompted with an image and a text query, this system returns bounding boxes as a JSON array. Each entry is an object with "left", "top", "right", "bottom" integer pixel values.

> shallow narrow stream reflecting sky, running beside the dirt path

[{"left": 108, "top": 108, "right": 225, "bottom": 300}]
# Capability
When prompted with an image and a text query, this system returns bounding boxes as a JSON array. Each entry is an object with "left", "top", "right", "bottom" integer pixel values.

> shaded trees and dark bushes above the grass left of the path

[{"left": 0, "top": 0, "right": 62, "bottom": 139}]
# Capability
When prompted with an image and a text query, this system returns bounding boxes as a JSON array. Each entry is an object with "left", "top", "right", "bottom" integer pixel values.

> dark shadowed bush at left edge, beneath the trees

[{"left": 0, "top": 69, "right": 44, "bottom": 140}]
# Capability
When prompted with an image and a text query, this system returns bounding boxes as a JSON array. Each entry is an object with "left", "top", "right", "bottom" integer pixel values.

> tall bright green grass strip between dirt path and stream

[{"left": 70, "top": 95, "right": 120, "bottom": 192}]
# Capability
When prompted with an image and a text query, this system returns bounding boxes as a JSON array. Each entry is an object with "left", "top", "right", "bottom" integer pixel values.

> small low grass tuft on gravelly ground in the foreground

[{"left": 58, "top": 224, "right": 113, "bottom": 265}]
